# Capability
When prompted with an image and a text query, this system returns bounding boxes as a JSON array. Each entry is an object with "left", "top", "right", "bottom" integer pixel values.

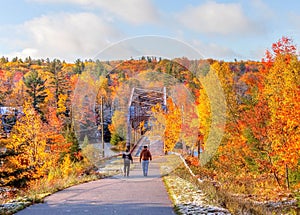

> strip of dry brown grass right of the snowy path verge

[{"left": 162, "top": 155, "right": 298, "bottom": 215}]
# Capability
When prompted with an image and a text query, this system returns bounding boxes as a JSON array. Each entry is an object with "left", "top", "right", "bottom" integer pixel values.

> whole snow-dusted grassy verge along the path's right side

[{"left": 161, "top": 155, "right": 299, "bottom": 215}]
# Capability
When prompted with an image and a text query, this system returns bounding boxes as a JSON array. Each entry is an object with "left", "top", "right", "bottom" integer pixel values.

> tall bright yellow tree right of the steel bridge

[{"left": 196, "top": 62, "right": 227, "bottom": 165}]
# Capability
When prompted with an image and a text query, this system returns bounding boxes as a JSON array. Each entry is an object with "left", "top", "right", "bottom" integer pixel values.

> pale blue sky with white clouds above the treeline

[{"left": 0, "top": 0, "right": 300, "bottom": 62}]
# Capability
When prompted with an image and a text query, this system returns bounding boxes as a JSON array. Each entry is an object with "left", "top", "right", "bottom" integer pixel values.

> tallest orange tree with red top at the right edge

[{"left": 262, "top": 37, "right": 300, "bottom": 187}]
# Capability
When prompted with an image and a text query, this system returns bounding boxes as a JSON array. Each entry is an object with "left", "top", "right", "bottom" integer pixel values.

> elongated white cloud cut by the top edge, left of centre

[{"left": 30, "top": 0, "right": 159, "bottom": 25}]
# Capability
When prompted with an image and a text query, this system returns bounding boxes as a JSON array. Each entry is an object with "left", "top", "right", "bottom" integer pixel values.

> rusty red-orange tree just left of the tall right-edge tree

[{"left": 238, "top": 72, "right": 272, "bottom": 180}]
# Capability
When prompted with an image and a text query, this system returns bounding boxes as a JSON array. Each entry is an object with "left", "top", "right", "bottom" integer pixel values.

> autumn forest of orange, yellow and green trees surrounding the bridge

[{"left": 0, "top": 37, "right": 300, "bottom": 209}]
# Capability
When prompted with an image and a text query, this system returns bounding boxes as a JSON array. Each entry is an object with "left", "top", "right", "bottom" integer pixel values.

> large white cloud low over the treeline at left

[{"left": 5, "top": 13, "right": 121, "bottom": 61}]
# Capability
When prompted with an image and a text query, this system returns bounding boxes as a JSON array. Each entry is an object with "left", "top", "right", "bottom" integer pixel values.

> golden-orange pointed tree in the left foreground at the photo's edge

[{"left": 1, "top": 103, "right": 48, "bottom": 187}]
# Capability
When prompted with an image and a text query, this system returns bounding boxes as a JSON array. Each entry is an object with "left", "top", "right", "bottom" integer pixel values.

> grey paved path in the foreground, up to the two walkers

[{"left": 17, "top": 157, "right": 175, "bottom": 215}]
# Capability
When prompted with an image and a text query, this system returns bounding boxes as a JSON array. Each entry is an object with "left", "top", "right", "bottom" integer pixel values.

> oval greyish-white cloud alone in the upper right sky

[{"left": 177, "top": 2, "right": 259, "bottom": 35}]
